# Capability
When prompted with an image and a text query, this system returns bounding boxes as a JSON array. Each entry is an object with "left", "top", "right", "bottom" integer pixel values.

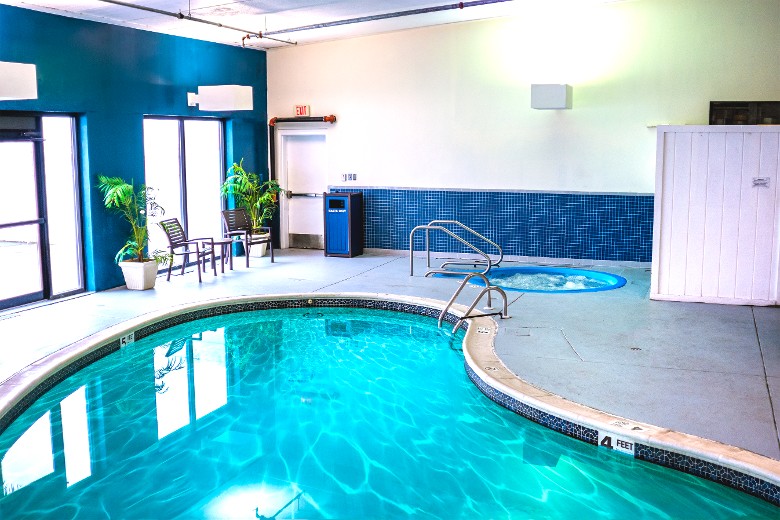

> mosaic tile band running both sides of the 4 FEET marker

[{"left": 466, "top": 365, "right": 780, "bottom": 506}]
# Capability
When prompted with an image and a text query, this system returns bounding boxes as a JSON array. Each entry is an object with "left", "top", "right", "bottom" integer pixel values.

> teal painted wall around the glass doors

[{"left": 0, "top": 5, "right": 268, "bottom": 290}]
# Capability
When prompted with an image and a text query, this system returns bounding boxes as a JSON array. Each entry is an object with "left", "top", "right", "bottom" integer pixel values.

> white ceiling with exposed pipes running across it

[{"left": 0, "top": 0, "right": 526, "bottom": 49}]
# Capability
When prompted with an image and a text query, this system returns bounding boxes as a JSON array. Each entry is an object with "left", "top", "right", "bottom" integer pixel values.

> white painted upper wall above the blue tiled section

[{"left": 268, "top": 0, "right": 780, "bottom": 193}]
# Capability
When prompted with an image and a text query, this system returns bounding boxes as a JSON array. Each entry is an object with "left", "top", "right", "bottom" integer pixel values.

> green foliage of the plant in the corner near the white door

[{"left": 221, "top": 159, "right": 284, "bottom": 227}]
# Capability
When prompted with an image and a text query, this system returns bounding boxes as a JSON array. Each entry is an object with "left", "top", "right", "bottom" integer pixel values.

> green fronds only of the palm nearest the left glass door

[{"left": 98, "top": 175, "right": 171, "bottom": 264}]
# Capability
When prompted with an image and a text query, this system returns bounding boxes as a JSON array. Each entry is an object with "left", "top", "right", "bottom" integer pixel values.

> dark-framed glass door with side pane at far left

[{"left": 0, "top": 115, "right": 84, "bottom": 309}]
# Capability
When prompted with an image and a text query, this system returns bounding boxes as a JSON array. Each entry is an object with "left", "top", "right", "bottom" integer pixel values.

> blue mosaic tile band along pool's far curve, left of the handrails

[{"left": 0, "top": 298, "right": 468, "bottom": 433}]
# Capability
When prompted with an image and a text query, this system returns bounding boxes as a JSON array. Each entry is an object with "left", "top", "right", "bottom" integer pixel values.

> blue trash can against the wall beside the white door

[{"left": 323, "top": 193, "right": 363, "bottom": 257}]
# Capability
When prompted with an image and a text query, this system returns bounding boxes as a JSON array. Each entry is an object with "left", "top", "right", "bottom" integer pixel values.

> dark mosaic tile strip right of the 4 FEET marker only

[{"left": 634, "top": 443, "right": 780, "bottom": 506}]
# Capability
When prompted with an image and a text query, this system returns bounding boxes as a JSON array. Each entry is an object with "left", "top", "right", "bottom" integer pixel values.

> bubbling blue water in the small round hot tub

[{"left": 482, "top": 266, "right": 626, "bottom": 293}]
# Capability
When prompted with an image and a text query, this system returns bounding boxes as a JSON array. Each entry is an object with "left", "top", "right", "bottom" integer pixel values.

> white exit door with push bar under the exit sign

[{"left": 279, "top": 133, "right": 328, "bottom": 249}]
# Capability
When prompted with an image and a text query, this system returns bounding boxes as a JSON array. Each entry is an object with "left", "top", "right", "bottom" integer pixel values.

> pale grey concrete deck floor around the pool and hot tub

[{"left": 0, "top": 250, "right": 780, "bottom": 460}]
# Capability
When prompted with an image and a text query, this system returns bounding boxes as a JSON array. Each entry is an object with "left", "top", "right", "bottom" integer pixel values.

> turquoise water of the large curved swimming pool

[{"left": 0, "top": 308, "right": 778, "bottom": 520}]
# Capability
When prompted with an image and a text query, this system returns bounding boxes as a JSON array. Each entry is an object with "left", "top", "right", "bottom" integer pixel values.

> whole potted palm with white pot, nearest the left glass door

[{"left": 98, "top": 175, "right": 170, "bottom": 290}]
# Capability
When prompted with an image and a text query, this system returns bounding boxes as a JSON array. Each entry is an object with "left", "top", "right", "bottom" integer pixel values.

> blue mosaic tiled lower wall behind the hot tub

[{"left": 333, "top": 188, "right": 654, "bottom": 262}]
